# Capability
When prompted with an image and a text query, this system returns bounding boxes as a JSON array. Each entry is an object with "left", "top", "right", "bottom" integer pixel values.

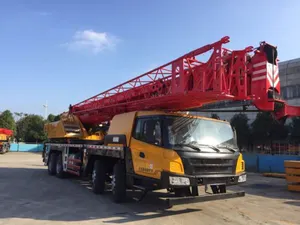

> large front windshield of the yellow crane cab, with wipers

[{"left": 163, "top": 116, "right": 238, "bottom": 151}]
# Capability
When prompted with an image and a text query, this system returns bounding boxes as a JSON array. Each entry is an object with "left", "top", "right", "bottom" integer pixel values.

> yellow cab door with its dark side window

[{"left": 130, "top": 116, "right": 164, "bottom": 179}]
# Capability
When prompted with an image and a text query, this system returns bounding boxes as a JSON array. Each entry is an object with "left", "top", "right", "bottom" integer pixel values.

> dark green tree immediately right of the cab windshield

[{"left": 230, "top": 113, "right": 250, "bottom": 148}]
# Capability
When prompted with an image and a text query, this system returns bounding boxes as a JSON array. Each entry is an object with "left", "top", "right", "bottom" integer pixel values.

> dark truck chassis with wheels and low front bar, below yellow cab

[{"left": 43, "top": 143, "right": 246, "bottom": 207}]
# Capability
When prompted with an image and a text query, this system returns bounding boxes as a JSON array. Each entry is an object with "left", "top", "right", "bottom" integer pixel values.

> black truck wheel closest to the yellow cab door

[{"left": 111, "top": 162, "right": 126, "bottom": 203}]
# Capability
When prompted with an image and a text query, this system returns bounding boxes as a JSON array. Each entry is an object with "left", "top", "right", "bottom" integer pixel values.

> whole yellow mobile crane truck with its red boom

[{"left": 43, "top": 37, "right": 299, "bottom": 205}]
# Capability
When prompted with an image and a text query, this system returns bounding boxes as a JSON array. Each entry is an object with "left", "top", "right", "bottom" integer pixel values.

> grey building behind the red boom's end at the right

[{"left": 193, "top": 58, "right": 300, "bottom": 123}]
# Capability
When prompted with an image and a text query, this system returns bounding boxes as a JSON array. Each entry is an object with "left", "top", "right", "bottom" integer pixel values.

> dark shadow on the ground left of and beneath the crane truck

[{"left": 0, "top": 167, "right": 201, "bottom": 223}]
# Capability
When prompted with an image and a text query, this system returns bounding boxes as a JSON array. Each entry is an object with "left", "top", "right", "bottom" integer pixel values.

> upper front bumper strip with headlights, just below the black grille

[{"left": 161, "top": 172, "right": 247, "bottom": 188}]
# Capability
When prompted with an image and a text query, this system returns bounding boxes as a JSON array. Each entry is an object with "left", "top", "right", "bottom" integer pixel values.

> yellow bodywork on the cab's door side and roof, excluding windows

[{"left": 108, "top": 111, "right": 228, "bottom": 179}]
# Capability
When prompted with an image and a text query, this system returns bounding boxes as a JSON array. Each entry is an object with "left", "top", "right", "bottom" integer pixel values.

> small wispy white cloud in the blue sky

[{"left": 65, "top": 30, "right": 119, "bottom": 54}]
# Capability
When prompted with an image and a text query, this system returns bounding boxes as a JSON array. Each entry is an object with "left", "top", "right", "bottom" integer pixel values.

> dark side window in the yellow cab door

[{"left": 133, "top": 118, "right": 162, "bottom": 145}]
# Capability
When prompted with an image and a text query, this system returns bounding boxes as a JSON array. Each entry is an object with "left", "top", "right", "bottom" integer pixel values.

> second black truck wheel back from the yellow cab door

[{"left": 92, "top": 160, "right": 106, "bottom": 194}]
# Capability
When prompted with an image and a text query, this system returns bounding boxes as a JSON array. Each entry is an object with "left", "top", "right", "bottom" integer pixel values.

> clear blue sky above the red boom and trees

[{"left": 0, "top": 0, "right": 300, "bottom": 118}]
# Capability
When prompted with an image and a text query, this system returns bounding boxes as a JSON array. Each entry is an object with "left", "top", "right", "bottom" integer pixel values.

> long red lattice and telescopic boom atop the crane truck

[{"left": 70, "top": 36, "right": 300, "bottom": 124}]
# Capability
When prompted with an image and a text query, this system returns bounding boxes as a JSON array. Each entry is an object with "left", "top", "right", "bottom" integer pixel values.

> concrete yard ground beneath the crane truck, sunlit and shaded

[{"left": 0, "top": 153, "right": 300, "bottom": 225}]
